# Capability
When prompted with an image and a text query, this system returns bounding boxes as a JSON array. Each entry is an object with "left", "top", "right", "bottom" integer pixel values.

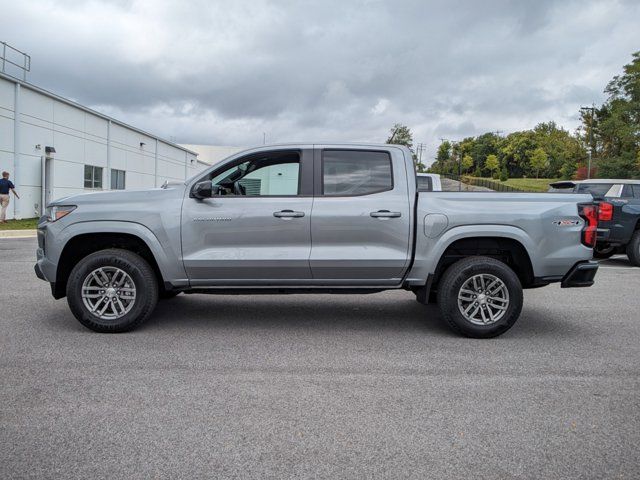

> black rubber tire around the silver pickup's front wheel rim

[{"left": 67, "top": 249, "right": 158, "bottom": 333}]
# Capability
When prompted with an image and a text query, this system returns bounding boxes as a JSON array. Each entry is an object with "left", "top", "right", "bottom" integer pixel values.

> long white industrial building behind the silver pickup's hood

[{"left": 0, "top": 67, "right": 207, "bottom": 219}]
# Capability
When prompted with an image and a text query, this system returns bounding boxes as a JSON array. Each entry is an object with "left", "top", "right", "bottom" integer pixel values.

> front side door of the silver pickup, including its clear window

[{"left": 182, "top": 149, "right": 313, "bottom": 286}]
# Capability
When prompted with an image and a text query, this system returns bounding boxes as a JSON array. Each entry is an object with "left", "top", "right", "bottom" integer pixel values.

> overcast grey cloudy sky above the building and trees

[{"left": 0, "top": 0, "right": 640, "bottom": 163}]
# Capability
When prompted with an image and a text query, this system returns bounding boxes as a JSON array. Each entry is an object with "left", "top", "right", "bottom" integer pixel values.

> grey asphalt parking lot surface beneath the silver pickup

[{"left": 0, "top": 239, "right": 640, "bottom": 479}]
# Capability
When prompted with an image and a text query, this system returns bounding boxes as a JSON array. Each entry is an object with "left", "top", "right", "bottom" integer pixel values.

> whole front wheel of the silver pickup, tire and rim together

[{"left": 67, "top": 249, "right": 158, "bottom": 333}]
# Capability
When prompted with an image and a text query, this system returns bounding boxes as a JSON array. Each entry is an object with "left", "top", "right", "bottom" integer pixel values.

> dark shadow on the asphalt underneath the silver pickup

[{"left": 126, "top": 294, "right": 570, "bottom": 338}]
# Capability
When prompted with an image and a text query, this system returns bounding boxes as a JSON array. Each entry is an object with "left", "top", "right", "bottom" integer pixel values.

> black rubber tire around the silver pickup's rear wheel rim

[{"left": 438, "top": 256, "right": 522, "bottom": 338}]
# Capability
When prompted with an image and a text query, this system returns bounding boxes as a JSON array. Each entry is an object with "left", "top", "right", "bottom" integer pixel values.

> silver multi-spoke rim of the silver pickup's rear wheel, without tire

[{"left": 458, "top": 273, "right": 509, "bottom": 325}]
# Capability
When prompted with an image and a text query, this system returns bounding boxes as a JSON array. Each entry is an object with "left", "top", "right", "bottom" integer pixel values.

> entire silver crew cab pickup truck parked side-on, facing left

[{"left": 35, "top": 144, "right": 598, "bottom": 338}]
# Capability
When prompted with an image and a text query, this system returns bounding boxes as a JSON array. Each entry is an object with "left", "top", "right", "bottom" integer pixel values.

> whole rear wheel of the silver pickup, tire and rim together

[{"left": 438, "top": 256, "right": 522, "bottom": 338}]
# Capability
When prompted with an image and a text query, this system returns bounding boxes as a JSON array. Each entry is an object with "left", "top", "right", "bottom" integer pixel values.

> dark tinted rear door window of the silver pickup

[{"left": 322, "top": 150, "right": 393, "bottom": 196}]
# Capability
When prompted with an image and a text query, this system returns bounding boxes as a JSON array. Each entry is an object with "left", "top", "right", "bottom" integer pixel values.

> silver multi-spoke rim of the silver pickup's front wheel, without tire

[{"left": 82, "top": 267, "right": 136, "bottom": 320}]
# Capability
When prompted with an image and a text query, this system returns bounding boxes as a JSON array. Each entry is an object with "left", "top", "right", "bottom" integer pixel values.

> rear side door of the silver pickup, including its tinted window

[{"left": 310, "top": 147, "right": 415, "bottom": 285}]
